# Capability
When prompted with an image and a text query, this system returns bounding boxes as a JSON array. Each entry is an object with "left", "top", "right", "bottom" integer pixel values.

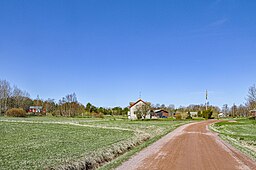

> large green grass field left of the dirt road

[{"left": 0, "top": 117, "right": 188, "bottom": 169}]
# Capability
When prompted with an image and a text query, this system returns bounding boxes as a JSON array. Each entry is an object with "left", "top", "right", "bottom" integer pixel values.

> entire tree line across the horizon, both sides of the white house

[{"left": 0, "top": 80, "right": 256, "bottom": 117}]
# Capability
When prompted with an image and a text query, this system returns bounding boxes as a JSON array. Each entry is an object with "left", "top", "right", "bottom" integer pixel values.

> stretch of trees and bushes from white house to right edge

[{"left": 135, "top": 85, "right": 256, "bottom": 119}]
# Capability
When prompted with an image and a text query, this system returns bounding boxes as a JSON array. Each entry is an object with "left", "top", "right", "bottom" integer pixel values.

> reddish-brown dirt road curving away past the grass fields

[{"left": 117, "top": 120, "right": 256, "bottom": 170}]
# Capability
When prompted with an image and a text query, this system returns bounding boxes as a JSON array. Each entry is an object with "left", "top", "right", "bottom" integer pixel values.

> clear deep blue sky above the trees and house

[{"left": 0, "top": 0, "right": 256, "bottom": 107}]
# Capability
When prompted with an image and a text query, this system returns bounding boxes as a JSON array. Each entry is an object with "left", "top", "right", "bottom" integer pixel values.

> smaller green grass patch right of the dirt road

[{"left": 211, "top": 119, "right": 256, "bottom": 160}]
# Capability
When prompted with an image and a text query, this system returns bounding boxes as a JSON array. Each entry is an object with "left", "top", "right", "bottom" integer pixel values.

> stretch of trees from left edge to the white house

[{"left": 0, "top": 80, "right": 129, "bottom": 117}]
